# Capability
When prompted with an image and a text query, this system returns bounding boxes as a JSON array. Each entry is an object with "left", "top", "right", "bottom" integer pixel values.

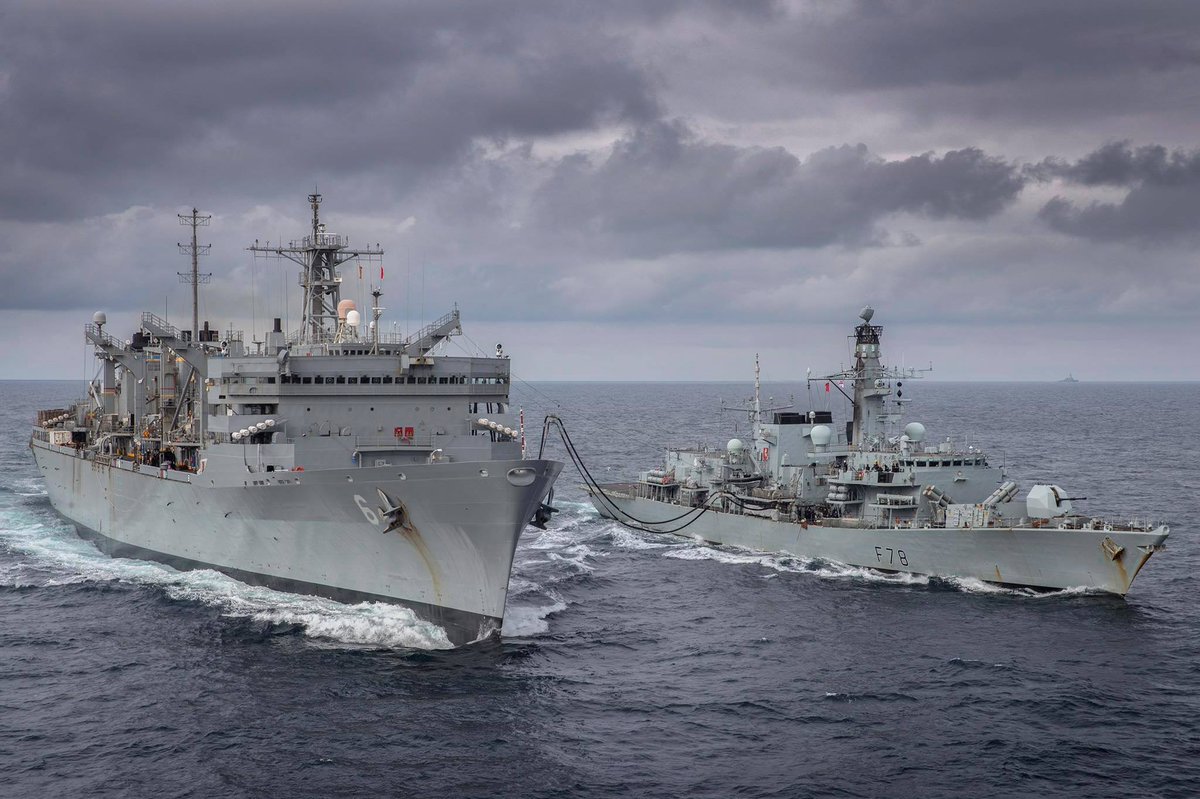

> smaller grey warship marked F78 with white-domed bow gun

[{"left": 588, "top": 307, "right": 1169, "bottom": 595}]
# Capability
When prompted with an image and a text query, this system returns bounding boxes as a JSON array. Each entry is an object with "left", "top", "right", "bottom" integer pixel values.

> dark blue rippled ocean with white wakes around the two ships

[{"left": 0, "top": 382, "right": 1200, "bottom": 799}]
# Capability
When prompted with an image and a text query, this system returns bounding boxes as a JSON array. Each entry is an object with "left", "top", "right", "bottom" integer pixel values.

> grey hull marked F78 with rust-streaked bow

[{"left": 593, "top": 493, "right": 1168, "bottom": 595}]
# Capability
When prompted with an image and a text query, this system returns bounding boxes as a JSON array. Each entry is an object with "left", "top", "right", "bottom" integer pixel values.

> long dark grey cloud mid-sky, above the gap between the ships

[{"left": 534, "top": 122, "right": 1025, "bottom": 256}]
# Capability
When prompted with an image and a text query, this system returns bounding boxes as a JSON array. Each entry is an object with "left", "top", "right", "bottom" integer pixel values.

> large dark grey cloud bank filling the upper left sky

[{"left": 0, "top": 2, "right": 659, "bottom": 220}]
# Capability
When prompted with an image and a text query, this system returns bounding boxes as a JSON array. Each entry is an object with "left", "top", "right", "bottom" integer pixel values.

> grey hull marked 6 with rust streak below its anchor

[{"left": 31, "top": 440, "right": 562, "bottom": 645}]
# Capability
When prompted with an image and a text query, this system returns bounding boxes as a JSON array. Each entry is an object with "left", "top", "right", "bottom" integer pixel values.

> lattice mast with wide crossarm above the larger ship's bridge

[{"left": 248, "top": 194, "right": 383, "bottom": 344}]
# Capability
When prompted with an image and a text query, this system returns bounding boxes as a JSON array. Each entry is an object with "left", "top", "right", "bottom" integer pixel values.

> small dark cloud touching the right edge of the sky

[{"left": 1030, "top": 142, "right": 1200, "bottom": 244}]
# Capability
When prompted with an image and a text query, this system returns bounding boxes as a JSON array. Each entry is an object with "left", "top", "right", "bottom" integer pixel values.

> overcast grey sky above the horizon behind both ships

[{"left": 0, "top": 0, "right": 1200, "bottom": 380}]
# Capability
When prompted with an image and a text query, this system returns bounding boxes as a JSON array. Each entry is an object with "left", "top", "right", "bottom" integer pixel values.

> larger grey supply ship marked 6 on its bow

[{"left": 30, "top": 194, "right": 562, "bottom": 645}]
